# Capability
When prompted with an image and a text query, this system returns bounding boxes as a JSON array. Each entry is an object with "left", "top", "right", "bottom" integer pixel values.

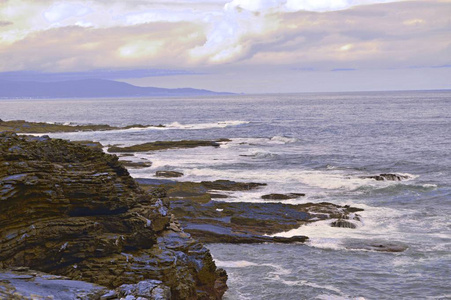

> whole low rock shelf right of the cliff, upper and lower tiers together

[{"left": 137, "top": 179, "right": 363, "bottom": 243}]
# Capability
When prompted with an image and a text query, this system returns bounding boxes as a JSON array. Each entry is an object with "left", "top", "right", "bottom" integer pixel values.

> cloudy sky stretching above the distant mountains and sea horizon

[{"left": 0, "top": 0, "right": 451, "bottom": 93}]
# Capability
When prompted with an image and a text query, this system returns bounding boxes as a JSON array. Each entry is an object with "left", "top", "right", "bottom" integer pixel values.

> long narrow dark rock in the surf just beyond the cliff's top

[{"left": 108, "top": 139, "right": 227, "bottom": 153}]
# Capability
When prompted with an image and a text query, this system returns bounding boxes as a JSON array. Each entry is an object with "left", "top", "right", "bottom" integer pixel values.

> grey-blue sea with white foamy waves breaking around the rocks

[{"left": 0, "top": 91, "right": 451, "bottom": 299}]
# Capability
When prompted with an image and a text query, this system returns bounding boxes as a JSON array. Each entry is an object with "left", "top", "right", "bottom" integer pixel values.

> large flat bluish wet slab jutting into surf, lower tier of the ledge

[{"left": 171, "top": 197, "right": 362, "bottom": 243}]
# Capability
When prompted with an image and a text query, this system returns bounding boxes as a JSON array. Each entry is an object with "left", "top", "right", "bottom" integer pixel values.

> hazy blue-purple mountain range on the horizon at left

[{"left": 0, "top": 79, "right": 232, "bottom": 98}]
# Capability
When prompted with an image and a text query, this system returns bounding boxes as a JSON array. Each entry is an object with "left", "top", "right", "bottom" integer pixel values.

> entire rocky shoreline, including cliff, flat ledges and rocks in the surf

[{"left": 0, "top": 121, "right": 414, "bottom": 299}]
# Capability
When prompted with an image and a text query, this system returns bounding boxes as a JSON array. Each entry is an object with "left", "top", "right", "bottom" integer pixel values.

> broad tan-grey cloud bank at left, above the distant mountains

[{"left": 0, "top": 22, "right": 205, "bottom": 72}]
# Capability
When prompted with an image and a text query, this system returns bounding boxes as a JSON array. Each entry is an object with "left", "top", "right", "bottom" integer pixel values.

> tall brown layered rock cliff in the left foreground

[{"left": 0, "top": 134, "right": 226, "bottom": 299}]
